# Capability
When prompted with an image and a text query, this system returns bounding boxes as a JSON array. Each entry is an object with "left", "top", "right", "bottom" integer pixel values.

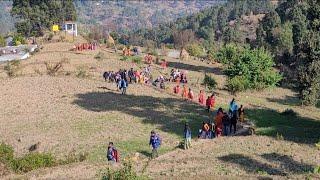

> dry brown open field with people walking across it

[{"left": 0, "top": 38, "right": 320, "bottom": 179}]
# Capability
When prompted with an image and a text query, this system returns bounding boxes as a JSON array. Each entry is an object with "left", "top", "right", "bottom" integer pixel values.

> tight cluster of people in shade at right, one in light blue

[{"left": 199, "top": 99, "right": 244, "bottom": 139}]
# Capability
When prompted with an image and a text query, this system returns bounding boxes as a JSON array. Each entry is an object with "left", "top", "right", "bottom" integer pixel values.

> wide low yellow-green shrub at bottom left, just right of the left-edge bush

[{"left": 10, "top": 153, "right": 55, "bottom": 173}]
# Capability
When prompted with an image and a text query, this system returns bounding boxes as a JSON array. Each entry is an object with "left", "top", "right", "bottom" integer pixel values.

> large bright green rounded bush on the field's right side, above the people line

[{"left": 217, "top": 45, "right": 282, "bottom": 92}]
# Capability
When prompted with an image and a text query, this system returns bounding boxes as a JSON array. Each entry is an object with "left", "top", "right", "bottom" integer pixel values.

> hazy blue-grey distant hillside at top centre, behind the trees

[{"left": 75, "top": 0, "right": 224, "bottom": 32}]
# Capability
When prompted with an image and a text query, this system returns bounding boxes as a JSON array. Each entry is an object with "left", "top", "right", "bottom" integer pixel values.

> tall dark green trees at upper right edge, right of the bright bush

[{"left": 257, "top": 0, "right": 320, "bottom": 105}]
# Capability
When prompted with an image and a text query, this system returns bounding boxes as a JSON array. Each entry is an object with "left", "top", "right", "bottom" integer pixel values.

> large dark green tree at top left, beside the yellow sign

[{"left": 11, "top": 0, "right": 76, "bottom": 37}]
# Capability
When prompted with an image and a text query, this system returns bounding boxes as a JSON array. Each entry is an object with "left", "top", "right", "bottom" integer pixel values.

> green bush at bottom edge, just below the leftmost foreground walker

[{"left": 102, "top": 162, "right": 147, "bottom": 180}]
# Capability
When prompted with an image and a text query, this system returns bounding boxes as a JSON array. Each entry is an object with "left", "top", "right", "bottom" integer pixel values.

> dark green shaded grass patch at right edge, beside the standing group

[{"left": 246, "top": 109, "right": 320, "bottom": 144}]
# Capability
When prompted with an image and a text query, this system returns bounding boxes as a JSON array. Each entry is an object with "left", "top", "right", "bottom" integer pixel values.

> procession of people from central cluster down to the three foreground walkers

[{"left": 103, "top": 61, "right": 248, "bottom": 162}]
